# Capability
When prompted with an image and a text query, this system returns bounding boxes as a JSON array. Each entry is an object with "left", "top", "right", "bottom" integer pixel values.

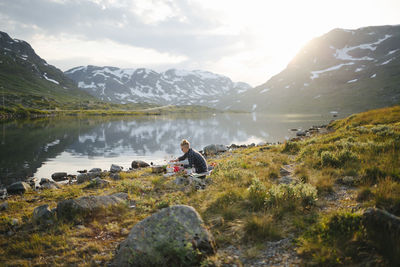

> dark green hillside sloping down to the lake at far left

[{"left": 0, "top": 32, "right": 95, "bottom": 108}]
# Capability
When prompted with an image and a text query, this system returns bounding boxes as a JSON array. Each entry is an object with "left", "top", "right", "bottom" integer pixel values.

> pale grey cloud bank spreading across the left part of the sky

[{"left": 0, "top": 0, "right": 244, "bottom": 60}]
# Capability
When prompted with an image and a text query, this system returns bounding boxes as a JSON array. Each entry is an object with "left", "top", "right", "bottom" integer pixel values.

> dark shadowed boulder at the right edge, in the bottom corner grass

[{"left": 363, "top": 208, "right": 400, "bottom": 266}]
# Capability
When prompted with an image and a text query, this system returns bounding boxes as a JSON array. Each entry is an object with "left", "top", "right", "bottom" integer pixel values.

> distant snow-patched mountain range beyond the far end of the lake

[{"left": 65, "top": 66, "right": 251, "bottom": 108}]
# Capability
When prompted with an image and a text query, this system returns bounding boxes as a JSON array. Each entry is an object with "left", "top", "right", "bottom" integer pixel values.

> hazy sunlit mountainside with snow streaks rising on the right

[{"left": 233, "top": 25, "right": 400, "bottom": 113}]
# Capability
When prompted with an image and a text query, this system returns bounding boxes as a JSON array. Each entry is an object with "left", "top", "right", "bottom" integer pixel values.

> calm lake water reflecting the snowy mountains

[{"left": 0, "top": 113, "right": 332, "bottom": 185}]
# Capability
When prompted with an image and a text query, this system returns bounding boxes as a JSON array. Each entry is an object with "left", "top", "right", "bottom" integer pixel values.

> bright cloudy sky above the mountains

[{"left": 0, "top": 0, "right": 400, "bottom": 86}]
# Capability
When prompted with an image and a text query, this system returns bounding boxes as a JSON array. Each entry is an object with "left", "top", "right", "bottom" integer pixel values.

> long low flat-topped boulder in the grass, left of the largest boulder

[{"left": 57, "top": 193, "right": 128, "bottom": 220}]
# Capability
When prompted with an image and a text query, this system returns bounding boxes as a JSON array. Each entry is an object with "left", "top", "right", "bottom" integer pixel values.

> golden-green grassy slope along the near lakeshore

[{"left": 0, "top": 106, "right": 400, "bottom": 266}]
